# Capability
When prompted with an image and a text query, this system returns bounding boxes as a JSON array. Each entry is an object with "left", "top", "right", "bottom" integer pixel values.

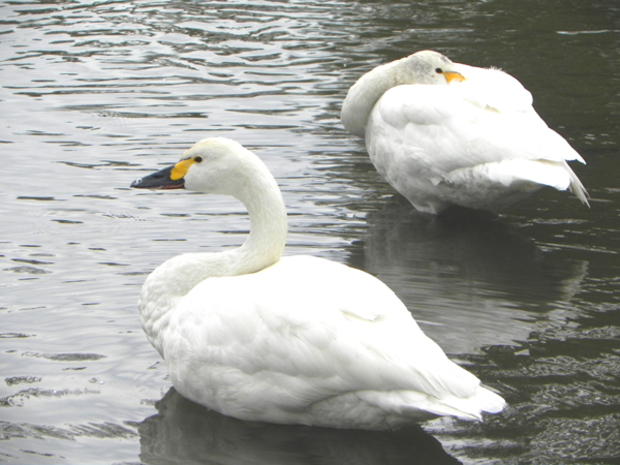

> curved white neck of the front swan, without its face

[{"left": 139, "top": 145, "right": 287, "bottom": 356}]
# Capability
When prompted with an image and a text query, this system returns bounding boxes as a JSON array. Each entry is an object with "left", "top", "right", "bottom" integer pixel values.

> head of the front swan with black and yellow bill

[{"left": 131, "top": 137, "right": 267, "bottom": 197}]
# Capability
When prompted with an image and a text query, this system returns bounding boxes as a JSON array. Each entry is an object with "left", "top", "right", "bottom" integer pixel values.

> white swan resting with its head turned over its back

[{"left": 340, "top": 50, "right": 588, "bottom": 214}]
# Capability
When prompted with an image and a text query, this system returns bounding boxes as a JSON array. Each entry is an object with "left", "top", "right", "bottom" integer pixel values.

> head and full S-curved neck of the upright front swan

[{"left": 131, "top": 137, "right": 288, "bottom": 358}]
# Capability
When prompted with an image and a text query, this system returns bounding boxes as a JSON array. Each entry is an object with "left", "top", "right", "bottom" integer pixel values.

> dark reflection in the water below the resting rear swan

[{"left": 349, "top": 195, "right": 588, "bottom": 354}]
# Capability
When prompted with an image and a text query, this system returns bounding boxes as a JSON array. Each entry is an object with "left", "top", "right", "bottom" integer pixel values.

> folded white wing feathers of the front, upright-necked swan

[{"left": 166, "top": 256, "right": 494, "bottom": 418}]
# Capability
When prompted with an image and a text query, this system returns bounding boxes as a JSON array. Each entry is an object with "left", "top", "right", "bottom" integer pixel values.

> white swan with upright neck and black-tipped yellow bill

[{"left": 132, "top": 138, "right": 505, "bottom": 429}]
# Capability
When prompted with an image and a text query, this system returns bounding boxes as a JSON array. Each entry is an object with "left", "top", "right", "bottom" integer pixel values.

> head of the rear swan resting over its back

[{"left": 396, "top": 50, "right": 465, "bottom": 85}]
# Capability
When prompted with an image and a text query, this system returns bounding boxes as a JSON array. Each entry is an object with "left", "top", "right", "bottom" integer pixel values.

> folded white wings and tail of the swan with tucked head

[{"left": 366, "top": 81, "right": 587, "bottom": 204}]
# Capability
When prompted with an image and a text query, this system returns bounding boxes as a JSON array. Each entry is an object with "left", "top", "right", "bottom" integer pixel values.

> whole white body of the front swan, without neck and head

[{"left": 164, "top": 256, "right": 504, "bottom": 429}]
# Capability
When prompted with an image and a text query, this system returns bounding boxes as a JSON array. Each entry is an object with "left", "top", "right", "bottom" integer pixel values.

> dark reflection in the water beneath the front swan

[{"left": 139, "top": 388, "right": 461, "bottom": 465}]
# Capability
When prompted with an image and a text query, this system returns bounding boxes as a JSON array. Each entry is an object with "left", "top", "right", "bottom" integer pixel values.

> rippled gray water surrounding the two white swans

[{"left": 0, "top": 0, "right": 620, "bottom": 465}]
